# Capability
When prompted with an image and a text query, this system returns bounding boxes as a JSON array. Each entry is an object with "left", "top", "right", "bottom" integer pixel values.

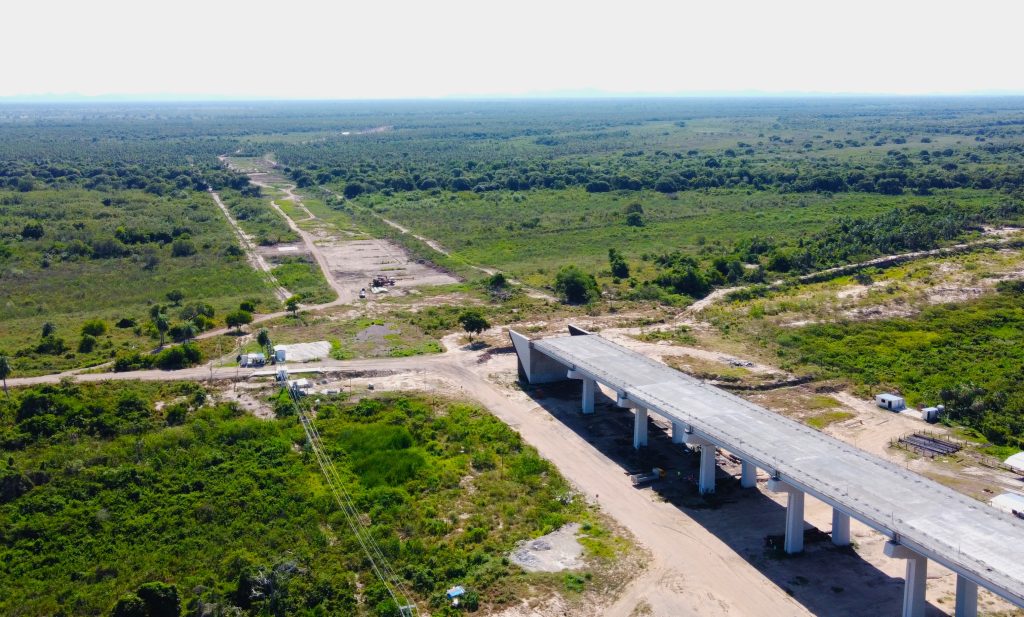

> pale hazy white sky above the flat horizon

[{"left": 8, "top": 0, "right": 1024, "bottom": 98}]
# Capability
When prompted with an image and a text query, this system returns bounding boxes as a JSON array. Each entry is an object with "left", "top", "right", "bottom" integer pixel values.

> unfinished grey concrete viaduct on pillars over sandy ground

[{"left": 510, "top": 326, "right": 1024, "bottom": 617}]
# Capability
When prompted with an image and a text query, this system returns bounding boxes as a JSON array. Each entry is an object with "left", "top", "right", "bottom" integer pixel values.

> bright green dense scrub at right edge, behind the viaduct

[{"left": 778, "top": 281, "right": 1024, "bottom": 448}]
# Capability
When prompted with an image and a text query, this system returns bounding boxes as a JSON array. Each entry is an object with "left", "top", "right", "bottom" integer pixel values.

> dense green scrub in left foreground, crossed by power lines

[{"left": 0, "top": 383, "right": 607, "bottom": 615}]
